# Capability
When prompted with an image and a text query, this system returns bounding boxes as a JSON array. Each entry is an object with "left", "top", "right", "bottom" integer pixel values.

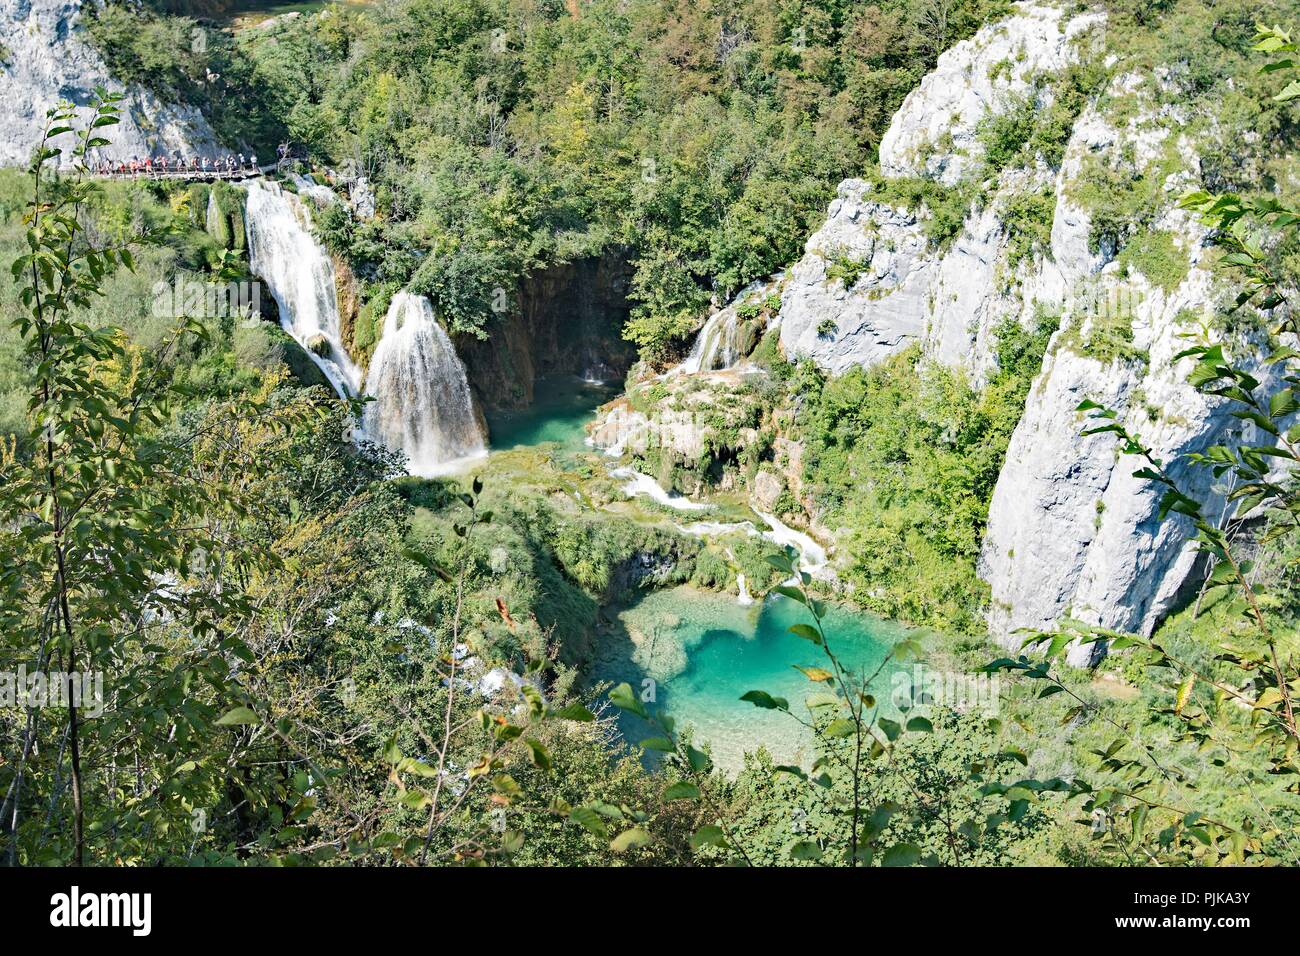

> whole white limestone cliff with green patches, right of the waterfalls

[{"left": 605, "top": 4, "right": 1268, "bottom": 663}]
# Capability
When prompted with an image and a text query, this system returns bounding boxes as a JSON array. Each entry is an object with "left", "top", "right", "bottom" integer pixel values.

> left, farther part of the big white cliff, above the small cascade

[{"left": 781, "top": 4, "right": 1105, "bottom": 377}]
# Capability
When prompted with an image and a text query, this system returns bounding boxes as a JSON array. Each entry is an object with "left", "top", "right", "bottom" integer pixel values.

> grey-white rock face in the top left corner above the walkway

[{"left": 0, "top": 0, "right": 220, "bottom": 165}]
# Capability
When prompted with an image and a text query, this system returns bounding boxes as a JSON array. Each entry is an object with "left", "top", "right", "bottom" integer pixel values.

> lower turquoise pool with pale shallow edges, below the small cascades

[{"left": 592, "top": 587, "right": 904, "bottom": 773}]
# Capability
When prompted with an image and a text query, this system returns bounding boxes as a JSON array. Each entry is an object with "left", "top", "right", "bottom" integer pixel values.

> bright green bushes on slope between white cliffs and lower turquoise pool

[{"left": 800, "top": 317, "right": 1056, "bottom": 633}]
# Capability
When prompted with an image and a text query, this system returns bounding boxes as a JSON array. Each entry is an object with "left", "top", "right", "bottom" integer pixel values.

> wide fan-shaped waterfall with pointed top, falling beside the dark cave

[{"left": 363, "top": 291, "right": 488, "bottom": 477}]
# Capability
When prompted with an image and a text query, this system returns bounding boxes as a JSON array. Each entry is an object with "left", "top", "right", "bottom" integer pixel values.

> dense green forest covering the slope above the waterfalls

[{"left": 90, "top": 0, "right": 1008, "bottom": 359}]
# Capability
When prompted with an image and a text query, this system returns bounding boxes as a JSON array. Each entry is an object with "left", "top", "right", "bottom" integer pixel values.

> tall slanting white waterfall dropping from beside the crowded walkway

[{"left": 244, "top": 179, "right": 361, "bottom": 398}]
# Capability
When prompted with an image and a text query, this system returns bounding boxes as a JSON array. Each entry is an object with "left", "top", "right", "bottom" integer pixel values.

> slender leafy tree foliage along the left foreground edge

[{"left": 0, "top": 98, "right": 325, "bottom": 865}]
